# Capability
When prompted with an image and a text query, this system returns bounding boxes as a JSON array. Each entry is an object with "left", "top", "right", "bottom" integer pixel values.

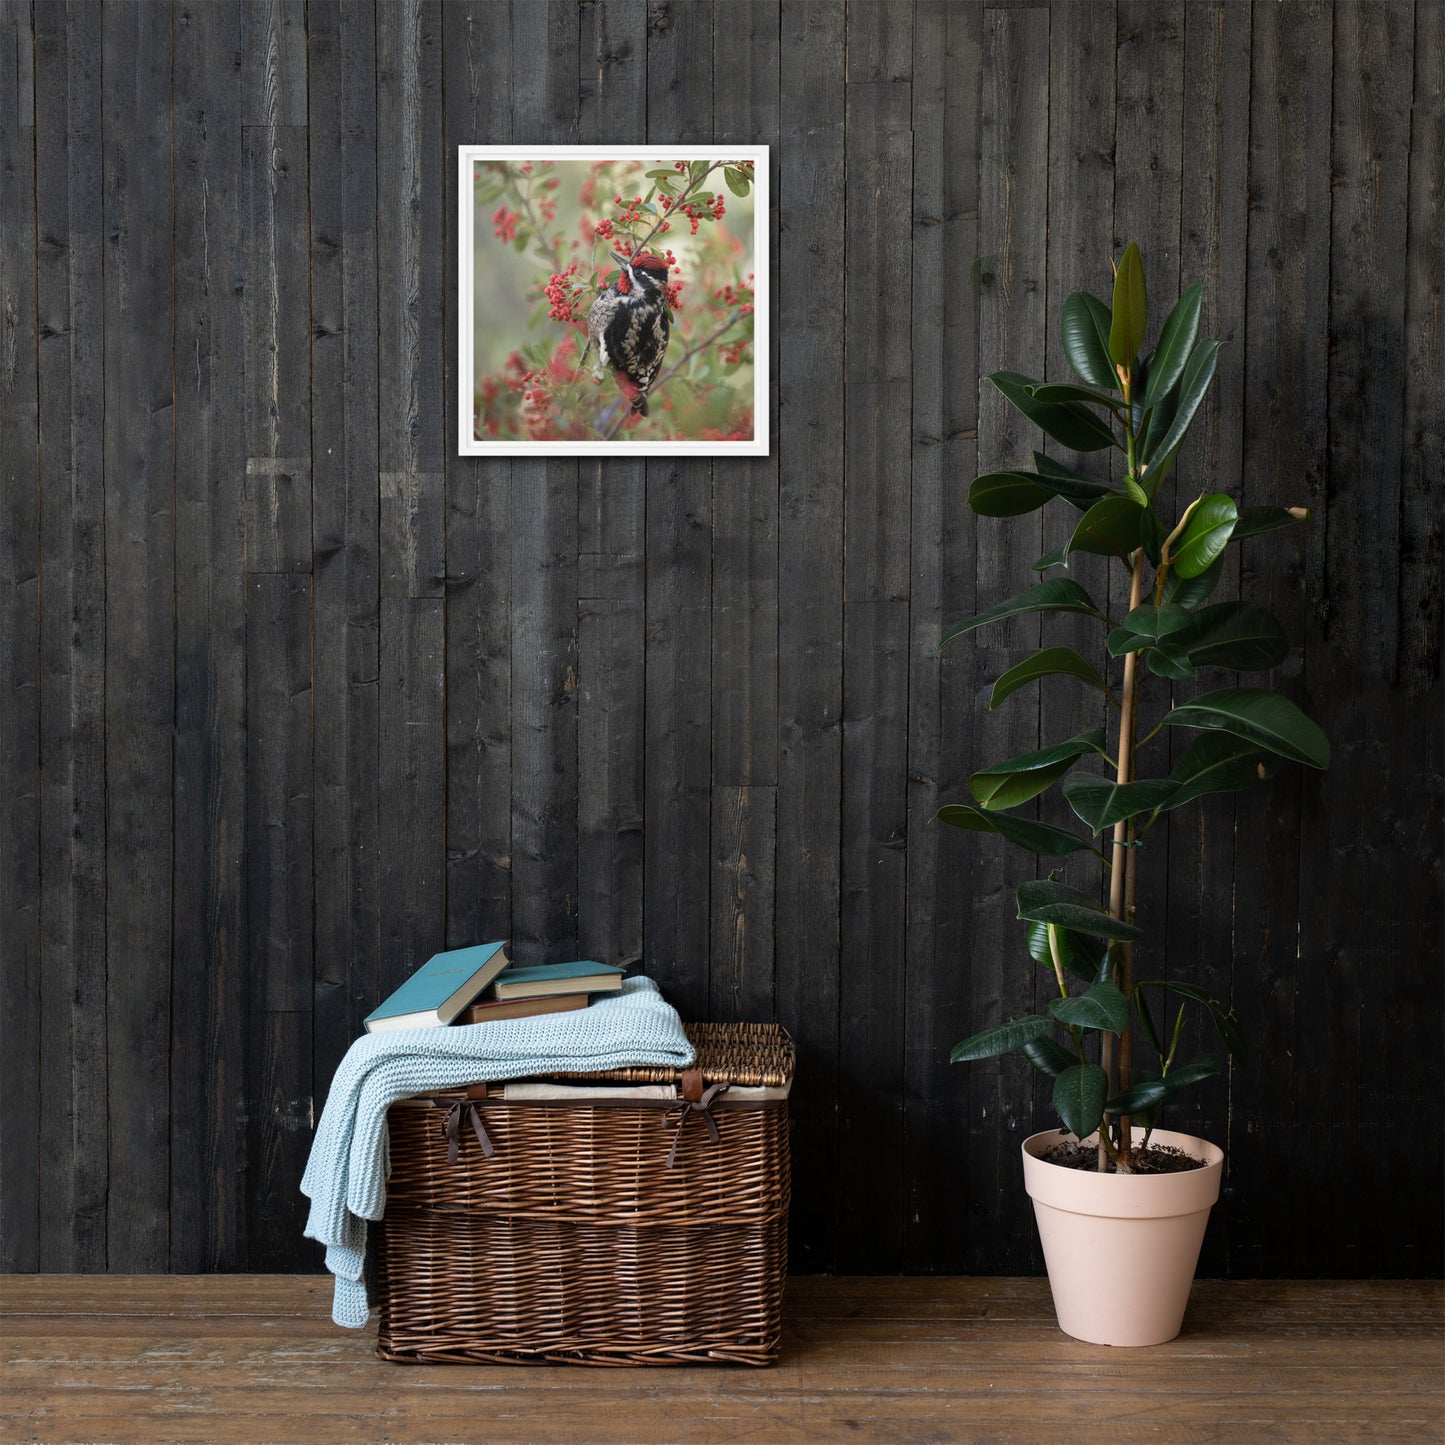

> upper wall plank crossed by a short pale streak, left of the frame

[{"left": 241, "top": 0, "right": 311, "bottom": 572}]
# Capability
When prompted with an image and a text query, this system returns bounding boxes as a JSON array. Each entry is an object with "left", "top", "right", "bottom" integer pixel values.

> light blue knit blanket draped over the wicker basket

[{"left": 301, "top": 977, "right": 694, "bottom": 1329}]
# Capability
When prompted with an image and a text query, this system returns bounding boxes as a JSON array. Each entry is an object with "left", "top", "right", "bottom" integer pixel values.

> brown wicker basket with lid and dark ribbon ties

[{"left": 376, "top": 1025, "right": 793, "bottom": 1366}]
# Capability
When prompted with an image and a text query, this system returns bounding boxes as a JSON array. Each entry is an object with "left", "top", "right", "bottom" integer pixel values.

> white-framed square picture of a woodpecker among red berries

[{"left": 457, "top": 146, "right": 769, "bottom": 457}]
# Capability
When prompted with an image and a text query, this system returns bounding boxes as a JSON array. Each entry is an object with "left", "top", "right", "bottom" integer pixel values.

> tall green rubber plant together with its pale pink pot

[{"left": 938, "top": 246, "right": 1329, "bottom": 1345}]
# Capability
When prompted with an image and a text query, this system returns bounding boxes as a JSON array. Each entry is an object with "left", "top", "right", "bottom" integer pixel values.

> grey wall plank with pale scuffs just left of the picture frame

[{"left": 376, "top": 0, "right": 451, "bottom": 598}]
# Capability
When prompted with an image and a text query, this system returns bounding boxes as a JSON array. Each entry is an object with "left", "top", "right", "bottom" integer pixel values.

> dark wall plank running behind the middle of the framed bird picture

[{"left": 577, "top": 0, "right": 644, "bottom": 964}]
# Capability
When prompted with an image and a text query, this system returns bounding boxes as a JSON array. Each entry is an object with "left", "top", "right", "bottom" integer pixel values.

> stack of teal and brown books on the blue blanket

[{"left": 366, "top": 942, "right": 623, "bottom": 1033}]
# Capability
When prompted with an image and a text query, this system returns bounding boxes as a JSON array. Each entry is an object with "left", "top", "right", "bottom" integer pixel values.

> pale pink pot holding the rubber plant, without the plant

[{"left": 1023, "top": 1129, "right": 1224, "bottom": 1345}]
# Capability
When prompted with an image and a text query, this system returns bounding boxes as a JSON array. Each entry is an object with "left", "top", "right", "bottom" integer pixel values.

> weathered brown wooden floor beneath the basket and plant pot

[{"left": 0, "top": 1276, "right": 1445, "bottom": 1445}]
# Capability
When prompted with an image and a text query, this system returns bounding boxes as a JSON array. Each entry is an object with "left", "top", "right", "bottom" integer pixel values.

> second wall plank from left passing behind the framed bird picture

[{"left": 512, "top": 0, "right": 579, "bottom": 964}]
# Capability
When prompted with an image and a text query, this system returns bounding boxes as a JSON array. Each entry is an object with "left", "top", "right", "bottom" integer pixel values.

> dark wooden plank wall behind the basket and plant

[{"left": 0, "top": 0, "right": 1445, "bottom": 1274}]
